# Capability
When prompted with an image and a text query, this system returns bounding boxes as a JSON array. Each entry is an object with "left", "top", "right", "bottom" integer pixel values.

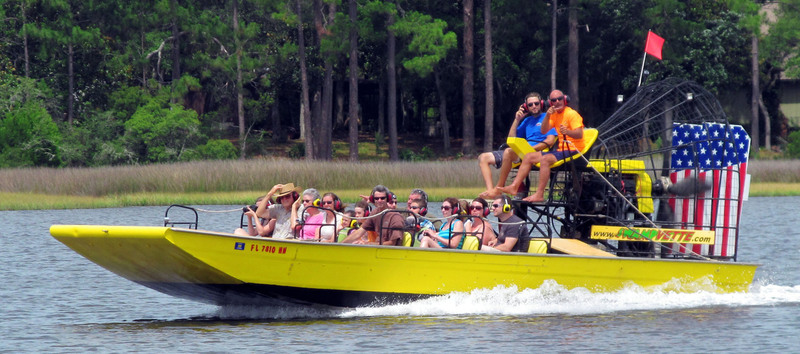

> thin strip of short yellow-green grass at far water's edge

[{"left": 0, "top": 183, "right": 800, "bottom": 211}]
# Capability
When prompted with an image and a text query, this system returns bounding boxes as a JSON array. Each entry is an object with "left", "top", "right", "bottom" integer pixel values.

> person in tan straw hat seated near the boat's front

[{"left": 256, "top": 183, "right": 300, "bottom": 239}]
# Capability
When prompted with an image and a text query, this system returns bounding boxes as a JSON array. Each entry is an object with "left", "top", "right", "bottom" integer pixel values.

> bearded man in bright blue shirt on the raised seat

[{"left": 478, "top": 92, "right": 558, "bottom": 200}]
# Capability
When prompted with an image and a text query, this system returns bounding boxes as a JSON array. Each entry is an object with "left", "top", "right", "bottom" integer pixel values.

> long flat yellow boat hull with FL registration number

[{"left": 50, "top": 225, "right": 757, "bottom": 307}]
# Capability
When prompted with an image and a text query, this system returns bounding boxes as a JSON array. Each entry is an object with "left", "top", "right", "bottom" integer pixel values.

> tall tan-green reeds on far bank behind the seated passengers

[{"left": 0, "top": 159, "right": 483, "bottom": 196}]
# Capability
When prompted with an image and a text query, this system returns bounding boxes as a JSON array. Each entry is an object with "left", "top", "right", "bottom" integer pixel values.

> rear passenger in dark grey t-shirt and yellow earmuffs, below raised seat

[{"left": 481, "top": 195, "right": 530, "bottom": 252}]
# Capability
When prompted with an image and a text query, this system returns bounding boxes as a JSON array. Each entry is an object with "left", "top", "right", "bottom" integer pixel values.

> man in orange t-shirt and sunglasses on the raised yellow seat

[{"left": 500, "top": 90, "right": 584, "bottom": 203}]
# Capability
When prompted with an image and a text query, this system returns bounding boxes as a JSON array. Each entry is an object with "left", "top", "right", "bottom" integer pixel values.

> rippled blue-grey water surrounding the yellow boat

[{"left": 0, "top": 197, "right": 800, "bottom": 352}]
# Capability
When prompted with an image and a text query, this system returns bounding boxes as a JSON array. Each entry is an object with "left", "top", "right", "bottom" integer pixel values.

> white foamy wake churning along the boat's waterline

[{"left": 214, "top": 281, "right": 800, "bottom": 320}]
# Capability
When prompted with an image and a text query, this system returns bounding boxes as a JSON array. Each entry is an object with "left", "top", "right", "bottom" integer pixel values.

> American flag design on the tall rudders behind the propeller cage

[{"left": 669, "top": 123, "right": 750, "bottom": 257}]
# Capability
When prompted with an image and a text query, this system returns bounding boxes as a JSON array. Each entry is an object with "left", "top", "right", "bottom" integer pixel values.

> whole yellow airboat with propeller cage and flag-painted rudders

[{"left": 50, "top": 79, "right": 757, "bottom": 307}]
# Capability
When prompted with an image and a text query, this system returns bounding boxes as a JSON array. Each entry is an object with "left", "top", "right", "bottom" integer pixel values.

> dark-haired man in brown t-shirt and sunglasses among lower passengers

[{"left": 343, "top": 185, "right": 405, "bottom": 246}]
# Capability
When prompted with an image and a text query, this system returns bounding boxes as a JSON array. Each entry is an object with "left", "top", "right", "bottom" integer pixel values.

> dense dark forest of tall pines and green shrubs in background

[{"left": 0, "top": 0, "right": 800, "bottom": 167}]
